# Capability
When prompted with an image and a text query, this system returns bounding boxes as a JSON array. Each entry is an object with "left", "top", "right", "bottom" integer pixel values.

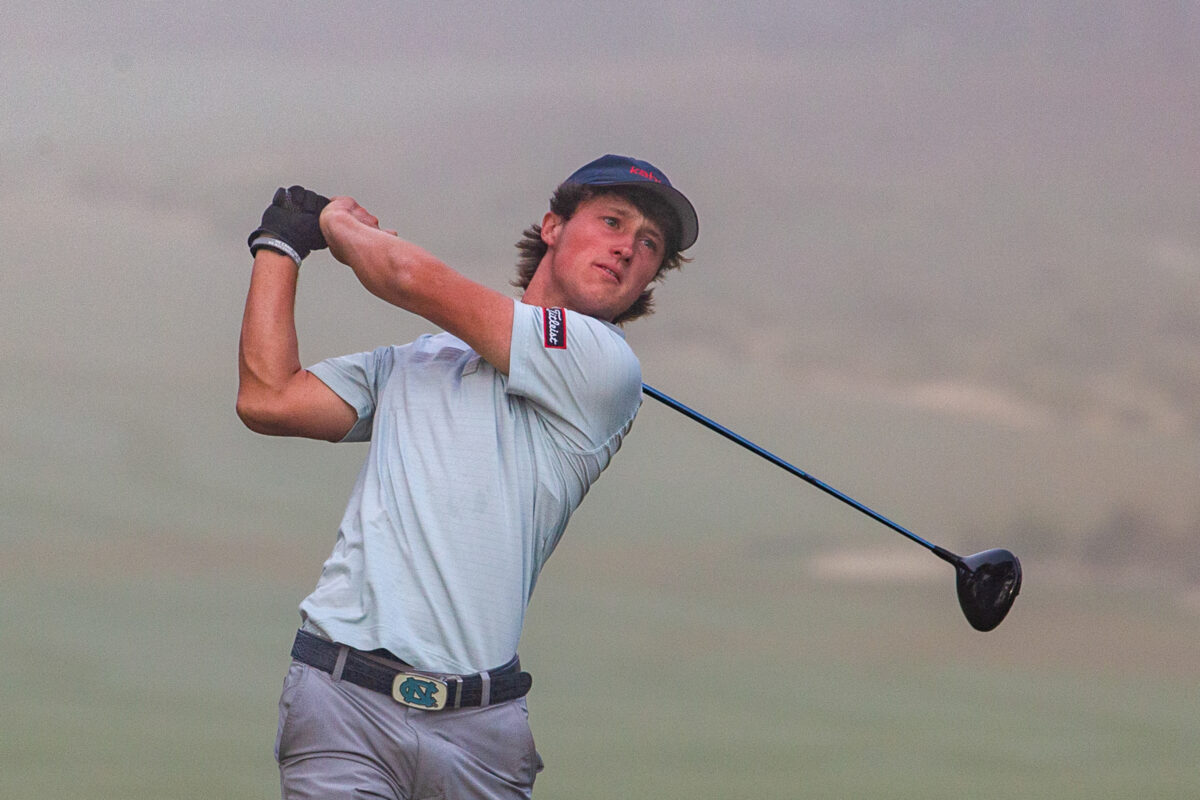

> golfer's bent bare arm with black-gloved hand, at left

[{"left": 238, "top": 190, "right": 358, "bottom": 441}]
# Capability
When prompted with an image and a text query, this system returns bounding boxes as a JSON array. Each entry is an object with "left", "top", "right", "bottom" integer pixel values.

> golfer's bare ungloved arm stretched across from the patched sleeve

[{"left": 320, "top": 197, "right": 512, "bottom": 374}]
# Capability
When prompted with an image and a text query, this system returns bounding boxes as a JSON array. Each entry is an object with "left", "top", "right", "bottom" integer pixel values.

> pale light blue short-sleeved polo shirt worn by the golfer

[{"left": 300, "top": 302, "right": 642, "bottom": 673}]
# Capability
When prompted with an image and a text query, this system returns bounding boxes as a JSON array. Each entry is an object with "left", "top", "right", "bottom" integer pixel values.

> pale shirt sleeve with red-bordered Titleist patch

[{"left": 508, "top": 302, "right": 642, "bottom": 451}]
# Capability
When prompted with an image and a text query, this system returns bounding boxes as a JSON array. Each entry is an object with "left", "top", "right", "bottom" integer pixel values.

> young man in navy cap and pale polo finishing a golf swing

[{"left": 238, "top": 156, "right": 697, "bottom": 799}]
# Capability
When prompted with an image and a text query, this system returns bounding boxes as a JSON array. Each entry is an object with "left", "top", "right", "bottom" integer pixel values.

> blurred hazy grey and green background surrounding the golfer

[{"left": 0, "top": 0, "right": 1200, "bottom": 799}]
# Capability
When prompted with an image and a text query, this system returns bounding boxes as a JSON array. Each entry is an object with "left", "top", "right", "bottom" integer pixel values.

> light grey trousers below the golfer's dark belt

[{"left": 275, "top": 661, "right": 542, "bottom": 800}]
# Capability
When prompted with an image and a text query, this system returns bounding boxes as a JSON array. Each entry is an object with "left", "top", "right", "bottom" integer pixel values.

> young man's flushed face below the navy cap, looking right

[{"left": 526, "top": 194, "right": 665, "bottom": 320}]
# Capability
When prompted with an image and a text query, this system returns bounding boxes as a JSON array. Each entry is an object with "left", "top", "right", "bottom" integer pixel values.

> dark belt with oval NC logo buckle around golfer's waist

[{"left": 292, "top": 631, "right": 533, "bottom": 711}]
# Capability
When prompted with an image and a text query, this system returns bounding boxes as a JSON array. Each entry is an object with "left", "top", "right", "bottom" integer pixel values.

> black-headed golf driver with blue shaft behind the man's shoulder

[{"left": 642, "top": 384, "right": 1021, "bottom": 631}]
